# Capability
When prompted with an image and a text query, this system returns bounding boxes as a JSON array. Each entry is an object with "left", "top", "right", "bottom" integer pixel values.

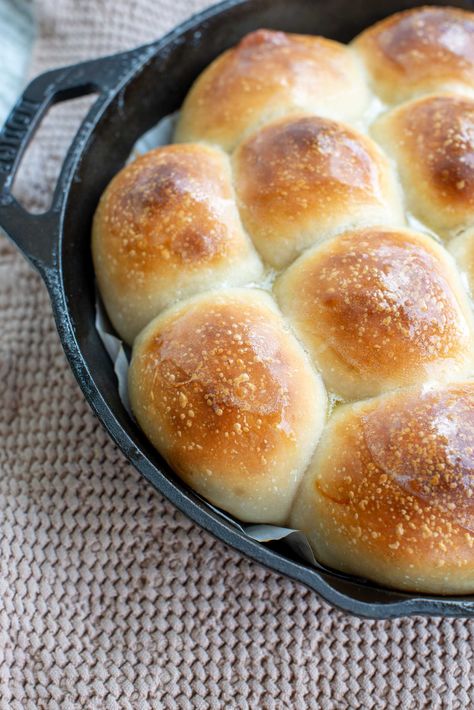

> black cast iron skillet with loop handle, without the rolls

[{"left": 0, "top": 0, "right": 474, "bottom": 619}]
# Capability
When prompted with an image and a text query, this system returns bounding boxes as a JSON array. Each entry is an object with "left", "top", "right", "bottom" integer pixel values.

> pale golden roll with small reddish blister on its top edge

[{"left": 175, "top": 30, "right": 369, "bottom": 150}]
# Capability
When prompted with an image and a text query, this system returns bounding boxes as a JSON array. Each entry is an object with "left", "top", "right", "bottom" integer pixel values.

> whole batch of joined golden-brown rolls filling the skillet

[{"left": 92, "top": 15, "right": 474, "bottom": 594}]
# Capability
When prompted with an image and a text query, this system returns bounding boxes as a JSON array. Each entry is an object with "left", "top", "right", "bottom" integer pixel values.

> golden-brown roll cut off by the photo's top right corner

[{"left": 352, "top": 7, "right": 474, "bottom": 103}]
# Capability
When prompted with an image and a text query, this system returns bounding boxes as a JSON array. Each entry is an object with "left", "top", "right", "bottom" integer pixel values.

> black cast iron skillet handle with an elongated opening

[{"left": 0, "top": 45, "right": 153, "bottom": 281}]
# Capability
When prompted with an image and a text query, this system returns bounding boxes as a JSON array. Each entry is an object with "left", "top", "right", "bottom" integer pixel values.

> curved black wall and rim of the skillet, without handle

[{"left": 57, "top": 0, "right": 474, "bottom": 618}]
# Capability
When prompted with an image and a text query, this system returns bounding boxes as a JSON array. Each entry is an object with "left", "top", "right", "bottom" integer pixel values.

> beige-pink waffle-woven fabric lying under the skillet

[{"left": 0, "top": 0, "right": 474, "bottom": 710}]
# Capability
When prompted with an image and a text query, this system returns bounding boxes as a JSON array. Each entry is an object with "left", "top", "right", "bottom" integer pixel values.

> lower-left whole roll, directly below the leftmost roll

[{"left": 129, "top": 289, "right": 326, "bottom": 524}]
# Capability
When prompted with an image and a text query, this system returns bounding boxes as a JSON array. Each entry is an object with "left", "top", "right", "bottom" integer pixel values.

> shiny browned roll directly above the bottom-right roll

[{"left": 276, "top": 227, "right": 474, "bottom": 400}]
